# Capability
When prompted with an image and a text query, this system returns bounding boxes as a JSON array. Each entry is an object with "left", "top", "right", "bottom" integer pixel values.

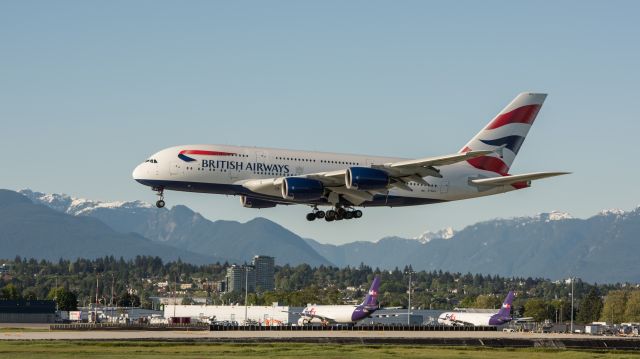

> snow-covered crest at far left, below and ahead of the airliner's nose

[{"left": 18, "top": 189, "right": 153, "bottom": 216}]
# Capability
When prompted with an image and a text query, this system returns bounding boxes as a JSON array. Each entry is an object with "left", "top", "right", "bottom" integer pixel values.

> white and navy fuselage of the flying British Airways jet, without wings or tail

[{"left": 133, "top": 145, "right": 514, "bottom": 207}]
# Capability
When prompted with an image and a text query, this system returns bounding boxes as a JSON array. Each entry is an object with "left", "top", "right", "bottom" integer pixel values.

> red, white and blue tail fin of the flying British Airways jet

[{"left": 460, "top": 93, "right": 547, "bottom": 175}]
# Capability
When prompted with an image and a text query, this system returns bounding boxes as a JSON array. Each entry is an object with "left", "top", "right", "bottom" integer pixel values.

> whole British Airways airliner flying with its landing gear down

[{"left": 133, "top": 93, "right": 568, "bottom": 222}]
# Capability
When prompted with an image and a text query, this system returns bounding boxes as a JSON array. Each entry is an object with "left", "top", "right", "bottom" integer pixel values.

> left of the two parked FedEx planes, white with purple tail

[{"left": 295, "top": 276, "right": 380, "bottom": 325}]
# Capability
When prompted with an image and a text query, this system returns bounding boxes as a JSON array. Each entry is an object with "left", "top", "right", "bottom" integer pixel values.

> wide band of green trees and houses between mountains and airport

[{"left": 0, "top": 256, "right": 640, "bottom": 323}]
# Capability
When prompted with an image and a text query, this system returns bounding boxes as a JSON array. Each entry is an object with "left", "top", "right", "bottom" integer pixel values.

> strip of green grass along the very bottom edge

[{"left": 0, "top": 341, "right": 640, "bottom": 359}]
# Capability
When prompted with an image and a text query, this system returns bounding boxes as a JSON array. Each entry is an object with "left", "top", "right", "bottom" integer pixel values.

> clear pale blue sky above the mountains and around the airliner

[{"left": 0, "top": 0, "right": 640, "bottom": 243}]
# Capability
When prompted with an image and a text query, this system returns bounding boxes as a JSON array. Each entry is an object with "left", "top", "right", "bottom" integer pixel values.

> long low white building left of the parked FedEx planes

[{"left": 164, "top": 305, "right": 303, "bottom": 324}]
